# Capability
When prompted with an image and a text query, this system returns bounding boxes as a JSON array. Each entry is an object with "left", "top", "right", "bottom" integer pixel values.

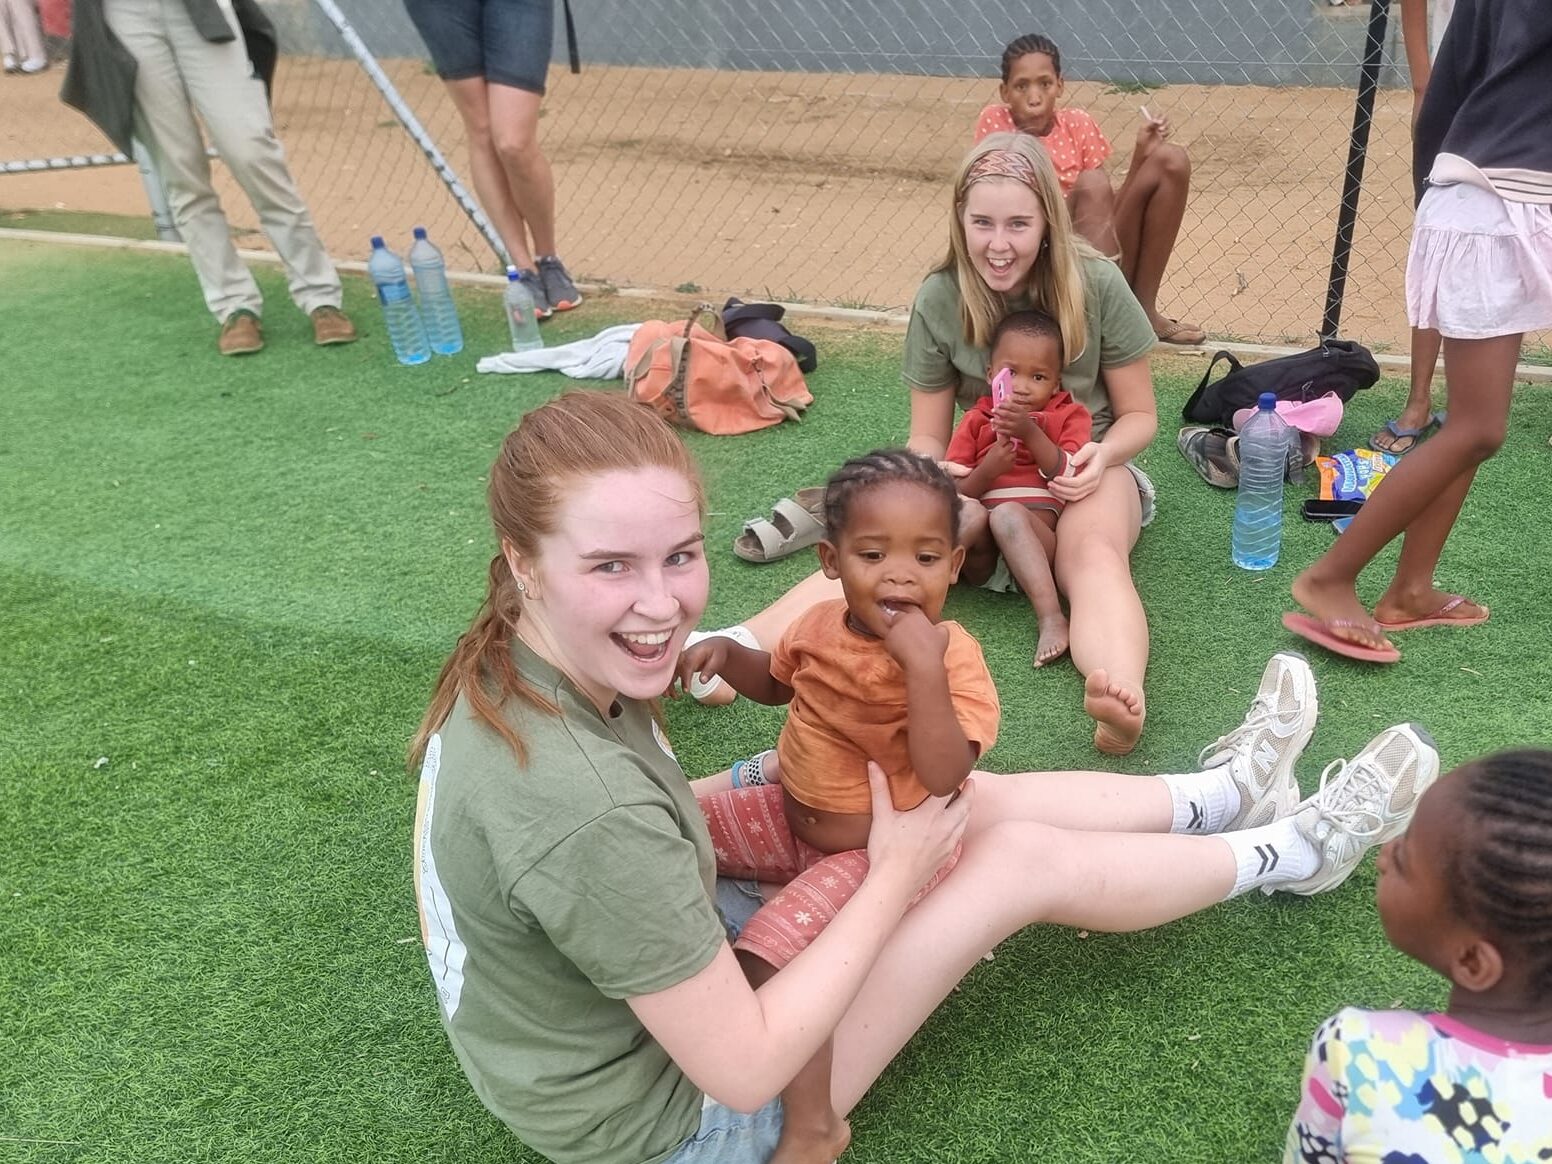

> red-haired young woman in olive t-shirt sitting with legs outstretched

[{"left": 411, "top": 393, "right": 1439, "bottom": 1164}]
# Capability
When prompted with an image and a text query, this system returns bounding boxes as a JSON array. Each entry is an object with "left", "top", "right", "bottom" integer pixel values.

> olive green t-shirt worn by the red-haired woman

[{"left": 414, "top": 644, "right": 726, "bottom": 1164}]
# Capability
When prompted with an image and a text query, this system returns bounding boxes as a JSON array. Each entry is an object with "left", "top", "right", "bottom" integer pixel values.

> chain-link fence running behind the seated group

[{"left": 0, "top": 0, "right": 1544, "bottom": 351}]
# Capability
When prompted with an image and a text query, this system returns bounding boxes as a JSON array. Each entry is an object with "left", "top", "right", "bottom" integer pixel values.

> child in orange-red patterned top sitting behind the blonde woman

[{"left": 975, "top": 34, "right": 1206, "bottom": 343}]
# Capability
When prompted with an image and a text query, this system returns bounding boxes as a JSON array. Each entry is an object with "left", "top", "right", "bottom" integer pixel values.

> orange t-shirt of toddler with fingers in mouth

[{"left": 771, "top": 599, "right": 1001, "bottom": 813}]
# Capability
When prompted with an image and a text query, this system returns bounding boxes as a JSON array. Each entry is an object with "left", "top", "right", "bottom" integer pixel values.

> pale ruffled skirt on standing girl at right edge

[{"left": 1406, "top": 182, "right": 1552, "bottom": 340}]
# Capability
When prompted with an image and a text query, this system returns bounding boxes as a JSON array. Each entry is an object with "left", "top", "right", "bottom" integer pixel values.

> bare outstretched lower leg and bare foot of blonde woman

[{"left": 1055, "top": 466, "right": 1148, "bottom": 756}]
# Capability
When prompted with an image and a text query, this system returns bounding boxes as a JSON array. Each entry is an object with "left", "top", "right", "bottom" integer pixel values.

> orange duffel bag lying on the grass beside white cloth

[{"left": 625, "top": 303, "right": 813, "bottom": 436}]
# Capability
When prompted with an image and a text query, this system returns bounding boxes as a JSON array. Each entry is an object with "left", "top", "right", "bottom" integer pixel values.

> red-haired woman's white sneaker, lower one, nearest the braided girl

[{"left": 1262, "top": 723, "right": 1439, "bottom": 894}]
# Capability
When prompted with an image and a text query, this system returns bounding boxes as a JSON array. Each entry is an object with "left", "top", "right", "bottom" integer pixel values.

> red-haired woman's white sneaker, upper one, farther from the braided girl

[{"left": 1201, "top": 650, "right": 1321, "bottom": 832}]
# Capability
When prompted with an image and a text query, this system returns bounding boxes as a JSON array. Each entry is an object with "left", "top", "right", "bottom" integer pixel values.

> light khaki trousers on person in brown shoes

[{"left": 104, "top": 0, "right": 340, "bottom": 321}]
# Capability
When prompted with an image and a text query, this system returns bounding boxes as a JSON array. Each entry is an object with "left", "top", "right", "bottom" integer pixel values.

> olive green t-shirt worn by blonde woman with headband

[{"left": 902, "top": 258, "right": 1158, "bottom": 441}]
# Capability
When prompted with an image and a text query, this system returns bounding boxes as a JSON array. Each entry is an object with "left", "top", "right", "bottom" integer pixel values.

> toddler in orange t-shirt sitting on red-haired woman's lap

[{"left": 678, "top": 449, "right": 1001, "bottom": 1164}]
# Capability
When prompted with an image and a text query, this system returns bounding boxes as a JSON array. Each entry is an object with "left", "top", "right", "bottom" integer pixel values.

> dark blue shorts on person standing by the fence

[{"left": 405, "top": 0, "right": 556, "bottom": 93}]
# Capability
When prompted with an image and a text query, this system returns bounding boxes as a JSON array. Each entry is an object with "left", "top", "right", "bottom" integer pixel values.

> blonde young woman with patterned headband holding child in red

[{"left": 712, "top": 133, "right": 1158, "bottom": 754}]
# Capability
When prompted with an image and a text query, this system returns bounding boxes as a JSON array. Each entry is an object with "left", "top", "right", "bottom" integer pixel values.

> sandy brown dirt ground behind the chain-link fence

[{"left": 0, "top": 57, "right": 1452, "bottom": 351}]
